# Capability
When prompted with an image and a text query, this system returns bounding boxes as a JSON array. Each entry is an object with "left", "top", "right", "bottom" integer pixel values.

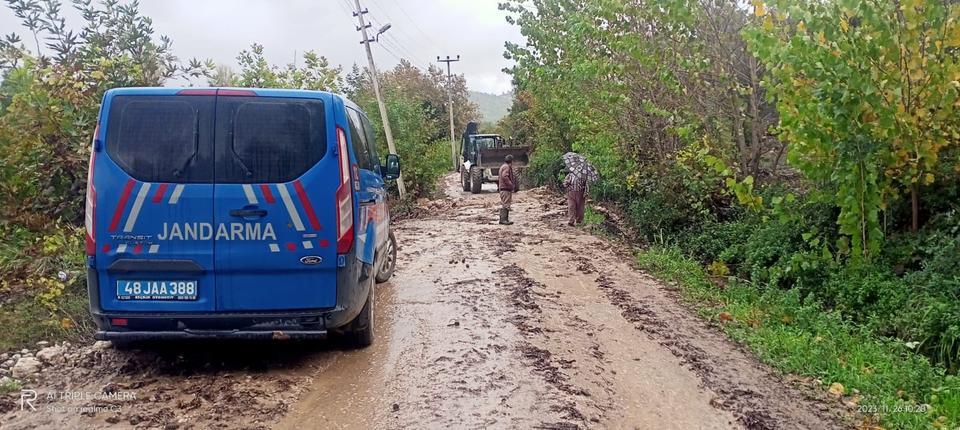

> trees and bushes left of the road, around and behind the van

[{"left": 0, "top": 0, "right": 468, "bottom": 351}]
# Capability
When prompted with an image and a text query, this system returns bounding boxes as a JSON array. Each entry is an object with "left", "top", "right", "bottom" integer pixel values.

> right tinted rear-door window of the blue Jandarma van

[{"left": 216, "top": 97, "right": 327, "bottom": 183}]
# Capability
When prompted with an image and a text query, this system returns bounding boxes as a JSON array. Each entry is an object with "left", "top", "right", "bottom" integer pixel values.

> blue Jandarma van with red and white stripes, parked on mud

[{"left": 80, "top": 88, "right": 400, "bottom": 347}]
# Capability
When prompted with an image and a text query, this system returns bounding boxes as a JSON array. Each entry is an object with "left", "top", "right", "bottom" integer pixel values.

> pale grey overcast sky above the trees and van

[{"left": 0, "top": 0, "right": 522, "bottom": 94}]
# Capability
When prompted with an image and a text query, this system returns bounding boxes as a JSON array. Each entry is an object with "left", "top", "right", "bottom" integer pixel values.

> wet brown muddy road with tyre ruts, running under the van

[{"left": 0, "top": 176, "right": 844, "bottom": 429}]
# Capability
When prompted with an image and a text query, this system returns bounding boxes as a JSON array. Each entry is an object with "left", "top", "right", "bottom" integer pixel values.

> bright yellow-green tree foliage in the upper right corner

[{"left": 745, "top": 0, "right": 960, "bottom": 257}]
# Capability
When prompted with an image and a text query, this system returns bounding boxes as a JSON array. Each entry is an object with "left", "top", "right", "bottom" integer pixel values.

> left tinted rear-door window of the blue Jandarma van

[{"left": 106, "top": 96, "right": 214, "bottom": 183}]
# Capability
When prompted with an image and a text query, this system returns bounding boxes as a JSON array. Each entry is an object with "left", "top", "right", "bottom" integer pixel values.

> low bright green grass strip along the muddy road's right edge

[{"left": 637, "top": 248, "right": 960, "bottom": 429}]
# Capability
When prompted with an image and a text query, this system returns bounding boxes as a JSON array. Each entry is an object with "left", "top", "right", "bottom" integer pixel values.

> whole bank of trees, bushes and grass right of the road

[{"left": 498, "top": 0, "right": 960, "bottom": 428}]
